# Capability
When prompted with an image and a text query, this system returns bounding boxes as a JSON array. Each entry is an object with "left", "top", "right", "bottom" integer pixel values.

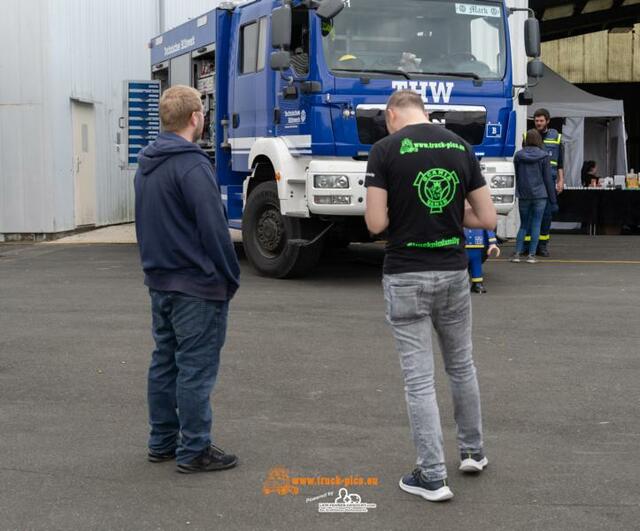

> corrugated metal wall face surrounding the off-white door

[{"left": 44, "top": 0, "right": 157, "bottom": 230}]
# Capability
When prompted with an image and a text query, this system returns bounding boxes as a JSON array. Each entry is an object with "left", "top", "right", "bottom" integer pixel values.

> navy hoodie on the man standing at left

[{"left": 134, "top": 133, "right": 240, "bottom": 301}]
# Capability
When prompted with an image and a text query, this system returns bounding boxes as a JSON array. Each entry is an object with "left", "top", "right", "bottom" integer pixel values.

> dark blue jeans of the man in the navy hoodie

[{"left": 148, "top": 289, "right": 229, "bottom": 463}]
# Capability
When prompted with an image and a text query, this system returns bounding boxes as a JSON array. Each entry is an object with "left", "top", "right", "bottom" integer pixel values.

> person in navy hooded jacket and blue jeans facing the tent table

[{"left": 511, "top": 129, "right": 558, "bottom": 264}]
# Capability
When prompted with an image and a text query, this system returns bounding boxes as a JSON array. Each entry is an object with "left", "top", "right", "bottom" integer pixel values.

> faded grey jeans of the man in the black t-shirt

[{"left": 383, "top": 270, "right": 482, "bottom": 481}]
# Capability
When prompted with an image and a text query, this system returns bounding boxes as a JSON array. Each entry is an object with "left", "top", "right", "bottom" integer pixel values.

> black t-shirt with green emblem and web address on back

[{"left": 365, "top": 124, "right": 486, "bottom": 274}]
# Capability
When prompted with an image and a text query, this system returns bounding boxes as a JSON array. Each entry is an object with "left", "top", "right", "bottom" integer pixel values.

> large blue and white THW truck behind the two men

[{"left": 145, "top": 0, "right": 540, "bottom": 278}]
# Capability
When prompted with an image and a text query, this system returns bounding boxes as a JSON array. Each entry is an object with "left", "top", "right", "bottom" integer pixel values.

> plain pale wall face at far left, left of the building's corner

[{"left": 0, "top": 0, "right": 53, "bottom": 232}]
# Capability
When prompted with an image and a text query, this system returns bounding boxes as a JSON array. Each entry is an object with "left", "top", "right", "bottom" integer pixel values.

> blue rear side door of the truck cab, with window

[{"left": 229, "top": 4, "right": 268, "bottom": 172}]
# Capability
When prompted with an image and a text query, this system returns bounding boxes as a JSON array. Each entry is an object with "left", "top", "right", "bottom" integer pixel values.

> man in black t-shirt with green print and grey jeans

[{"left": 365, "top": 91, "right": 496, "bottom": 501}]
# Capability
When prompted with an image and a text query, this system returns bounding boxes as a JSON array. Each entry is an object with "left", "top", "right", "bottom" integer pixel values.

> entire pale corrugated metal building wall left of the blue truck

[{"left": 0, "top": 0, "right": 230, "bottom": 234}]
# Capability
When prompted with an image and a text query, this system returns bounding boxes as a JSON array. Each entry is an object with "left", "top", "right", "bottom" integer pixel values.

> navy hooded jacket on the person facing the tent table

[{"left": 513, "top": 146, "right": 556, "bottom": 203}]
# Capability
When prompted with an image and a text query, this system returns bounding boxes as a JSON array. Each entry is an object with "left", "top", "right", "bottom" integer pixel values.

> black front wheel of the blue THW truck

[{"left": 242, "top": 181, "right": 323, "bottom": 278}]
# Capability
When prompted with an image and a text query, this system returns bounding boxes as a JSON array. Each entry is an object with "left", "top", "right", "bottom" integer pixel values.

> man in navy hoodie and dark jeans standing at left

[{"left": 135, "top": 86, "right": 240, "bottom": 473}]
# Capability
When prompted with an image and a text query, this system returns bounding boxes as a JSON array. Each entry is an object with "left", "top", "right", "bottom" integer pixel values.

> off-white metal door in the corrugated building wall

[{"left": 71, "top": 100, "right": 96, "bottom": 227}]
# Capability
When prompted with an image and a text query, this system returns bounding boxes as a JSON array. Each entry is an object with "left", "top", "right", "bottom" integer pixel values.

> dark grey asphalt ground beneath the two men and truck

[{"left": 0, "top": 236, "right": 640, "bottom": 531}]
